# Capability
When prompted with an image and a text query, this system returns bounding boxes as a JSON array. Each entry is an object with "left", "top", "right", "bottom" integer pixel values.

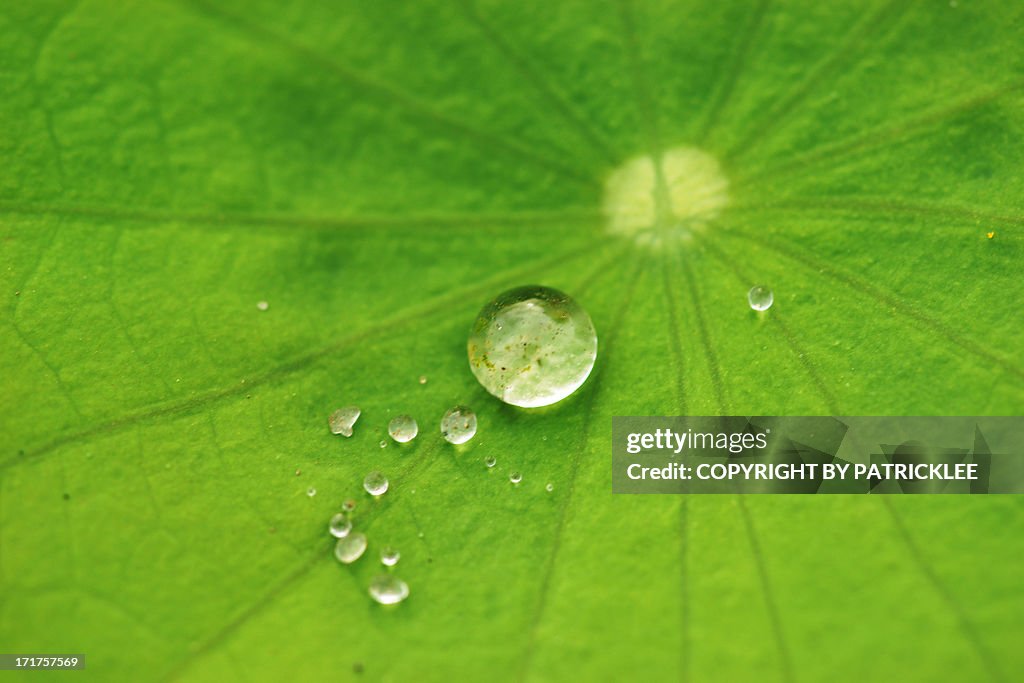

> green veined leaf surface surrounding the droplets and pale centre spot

[{"left": 0, "top": 0, "right": 1024, "bottom": 682}]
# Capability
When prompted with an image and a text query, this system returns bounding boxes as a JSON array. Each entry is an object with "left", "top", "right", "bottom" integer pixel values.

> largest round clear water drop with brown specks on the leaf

[{"left": 467, "top": 286, "right": 597, "bottom": 408}]
